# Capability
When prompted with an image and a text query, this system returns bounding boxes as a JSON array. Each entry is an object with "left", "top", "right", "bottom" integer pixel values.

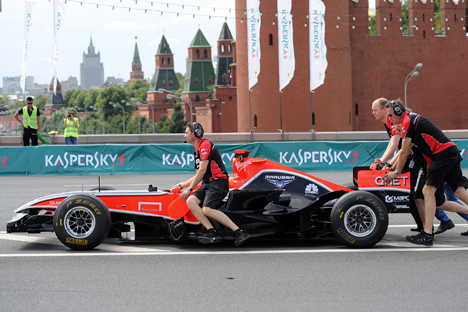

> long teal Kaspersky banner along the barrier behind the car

[{"left": 0, "top": 140, "right": 468, "bottom": 176}]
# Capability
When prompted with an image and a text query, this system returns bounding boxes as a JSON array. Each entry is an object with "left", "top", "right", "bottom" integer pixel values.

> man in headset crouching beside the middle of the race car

[{"left": 176, "top": 122, "right": 250, "bottom": 246}]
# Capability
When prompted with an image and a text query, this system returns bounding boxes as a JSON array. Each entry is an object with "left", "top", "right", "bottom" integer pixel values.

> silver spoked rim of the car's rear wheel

[{"left": 344, "top": 205, "right": 377, "bottom": 237}]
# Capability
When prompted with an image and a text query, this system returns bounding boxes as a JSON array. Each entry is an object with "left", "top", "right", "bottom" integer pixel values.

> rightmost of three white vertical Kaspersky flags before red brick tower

[{"left": 309, "top": 0, "right": 328, "bottom": 91}]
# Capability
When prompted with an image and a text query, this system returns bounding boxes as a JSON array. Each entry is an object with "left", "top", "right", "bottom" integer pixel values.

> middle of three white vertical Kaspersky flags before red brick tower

[{"left": 278, "top": 0, "right": 296, "bottom": 91}]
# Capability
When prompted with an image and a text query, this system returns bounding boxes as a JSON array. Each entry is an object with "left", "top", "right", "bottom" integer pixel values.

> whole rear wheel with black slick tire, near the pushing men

[{"left": 330, "top": 191, "right": 388, "bottom": 248}]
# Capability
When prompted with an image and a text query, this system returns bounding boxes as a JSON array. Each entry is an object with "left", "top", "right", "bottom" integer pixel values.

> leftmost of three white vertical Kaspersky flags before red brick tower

[{"left": 247, "top": 0, "right": 261, "bottom": 90}]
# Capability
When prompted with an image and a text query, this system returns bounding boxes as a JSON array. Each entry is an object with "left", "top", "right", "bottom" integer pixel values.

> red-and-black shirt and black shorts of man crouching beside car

[{"left": 193, "top": 138, "right": 229, "bottom": 209}]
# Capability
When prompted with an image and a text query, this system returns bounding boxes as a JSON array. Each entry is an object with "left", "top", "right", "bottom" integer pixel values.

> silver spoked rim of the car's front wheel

[{"left": 64, "top": 207, "right": 96, "bottom": 238}]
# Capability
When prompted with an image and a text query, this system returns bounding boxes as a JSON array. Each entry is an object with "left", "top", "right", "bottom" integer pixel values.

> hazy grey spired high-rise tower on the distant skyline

[{"left": 80, "top": 38, "right": 104, "bottom": 90}]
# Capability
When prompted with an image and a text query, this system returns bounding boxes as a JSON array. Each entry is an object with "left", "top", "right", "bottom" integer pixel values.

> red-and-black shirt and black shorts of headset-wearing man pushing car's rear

[{"left": 401, "top": 112, "right": 466, "bottom": 197}]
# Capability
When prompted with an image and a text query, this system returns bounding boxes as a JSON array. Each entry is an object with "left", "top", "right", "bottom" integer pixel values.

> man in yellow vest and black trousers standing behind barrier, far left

[{"left": 13, "top": 96, "right": 41, "bottom": 146}]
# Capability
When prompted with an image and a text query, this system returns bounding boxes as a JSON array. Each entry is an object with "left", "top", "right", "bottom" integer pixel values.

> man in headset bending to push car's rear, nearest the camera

[{"left": 384, "top": 100, "right": 468, "bottom": 246}]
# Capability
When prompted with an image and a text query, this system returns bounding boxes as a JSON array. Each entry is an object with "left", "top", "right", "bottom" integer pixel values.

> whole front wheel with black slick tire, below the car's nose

[{"left": 54, "top": 194, "right": 111, "bottom": 250}]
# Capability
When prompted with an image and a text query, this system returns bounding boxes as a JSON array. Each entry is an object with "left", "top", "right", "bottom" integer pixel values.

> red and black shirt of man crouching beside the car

[{"left": 193, "top": 138, "right": 229, "bottom": 183}]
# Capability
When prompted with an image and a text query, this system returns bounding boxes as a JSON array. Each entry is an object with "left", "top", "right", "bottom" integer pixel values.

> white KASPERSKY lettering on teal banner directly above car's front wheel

[{"left": 45, "top": 152, "right": 125, "bottom": 169}]
